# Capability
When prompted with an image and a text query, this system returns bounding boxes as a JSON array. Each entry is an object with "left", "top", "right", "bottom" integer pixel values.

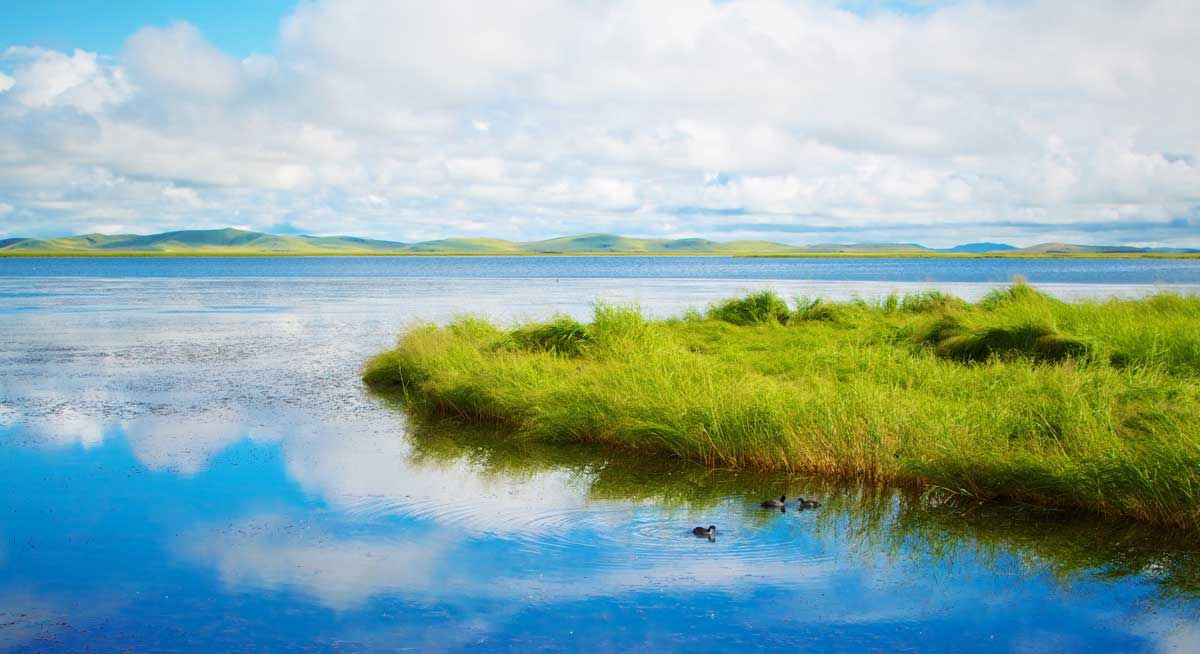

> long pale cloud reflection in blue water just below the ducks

[{"left": 178, "top": 514, "right": 854, "bottom": 614}]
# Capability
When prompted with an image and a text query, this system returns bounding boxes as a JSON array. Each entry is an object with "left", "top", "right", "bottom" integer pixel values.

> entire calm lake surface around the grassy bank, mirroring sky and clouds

[{"left": 0, "top": 257, "right": 1200, "bottom": 652}]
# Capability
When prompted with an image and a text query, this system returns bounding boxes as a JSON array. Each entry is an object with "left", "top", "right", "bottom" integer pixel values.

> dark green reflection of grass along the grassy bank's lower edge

[{"left": 409, "top": 421, "right": 1200, "bottom": 599}]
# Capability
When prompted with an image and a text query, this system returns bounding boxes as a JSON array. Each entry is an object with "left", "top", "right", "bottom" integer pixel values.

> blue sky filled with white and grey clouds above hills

[{"left": 0, "top": 0, "right": 1200, "bottom": 247}]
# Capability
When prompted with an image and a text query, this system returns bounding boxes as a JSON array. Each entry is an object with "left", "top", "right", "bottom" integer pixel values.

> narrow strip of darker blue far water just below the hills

[{"left": 7, "top": 257, "right": 1200, "bottom": 284}]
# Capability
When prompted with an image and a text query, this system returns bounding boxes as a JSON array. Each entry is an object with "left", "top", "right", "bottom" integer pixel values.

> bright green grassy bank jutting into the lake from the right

[{"left": 365, "top": 284, "right": 1200, "bottom": 529}]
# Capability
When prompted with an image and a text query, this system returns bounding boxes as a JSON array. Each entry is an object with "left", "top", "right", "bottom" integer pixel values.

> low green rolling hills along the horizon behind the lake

[{"left": 0, "top": 228, "right": 1200, "bottom": 257}]
